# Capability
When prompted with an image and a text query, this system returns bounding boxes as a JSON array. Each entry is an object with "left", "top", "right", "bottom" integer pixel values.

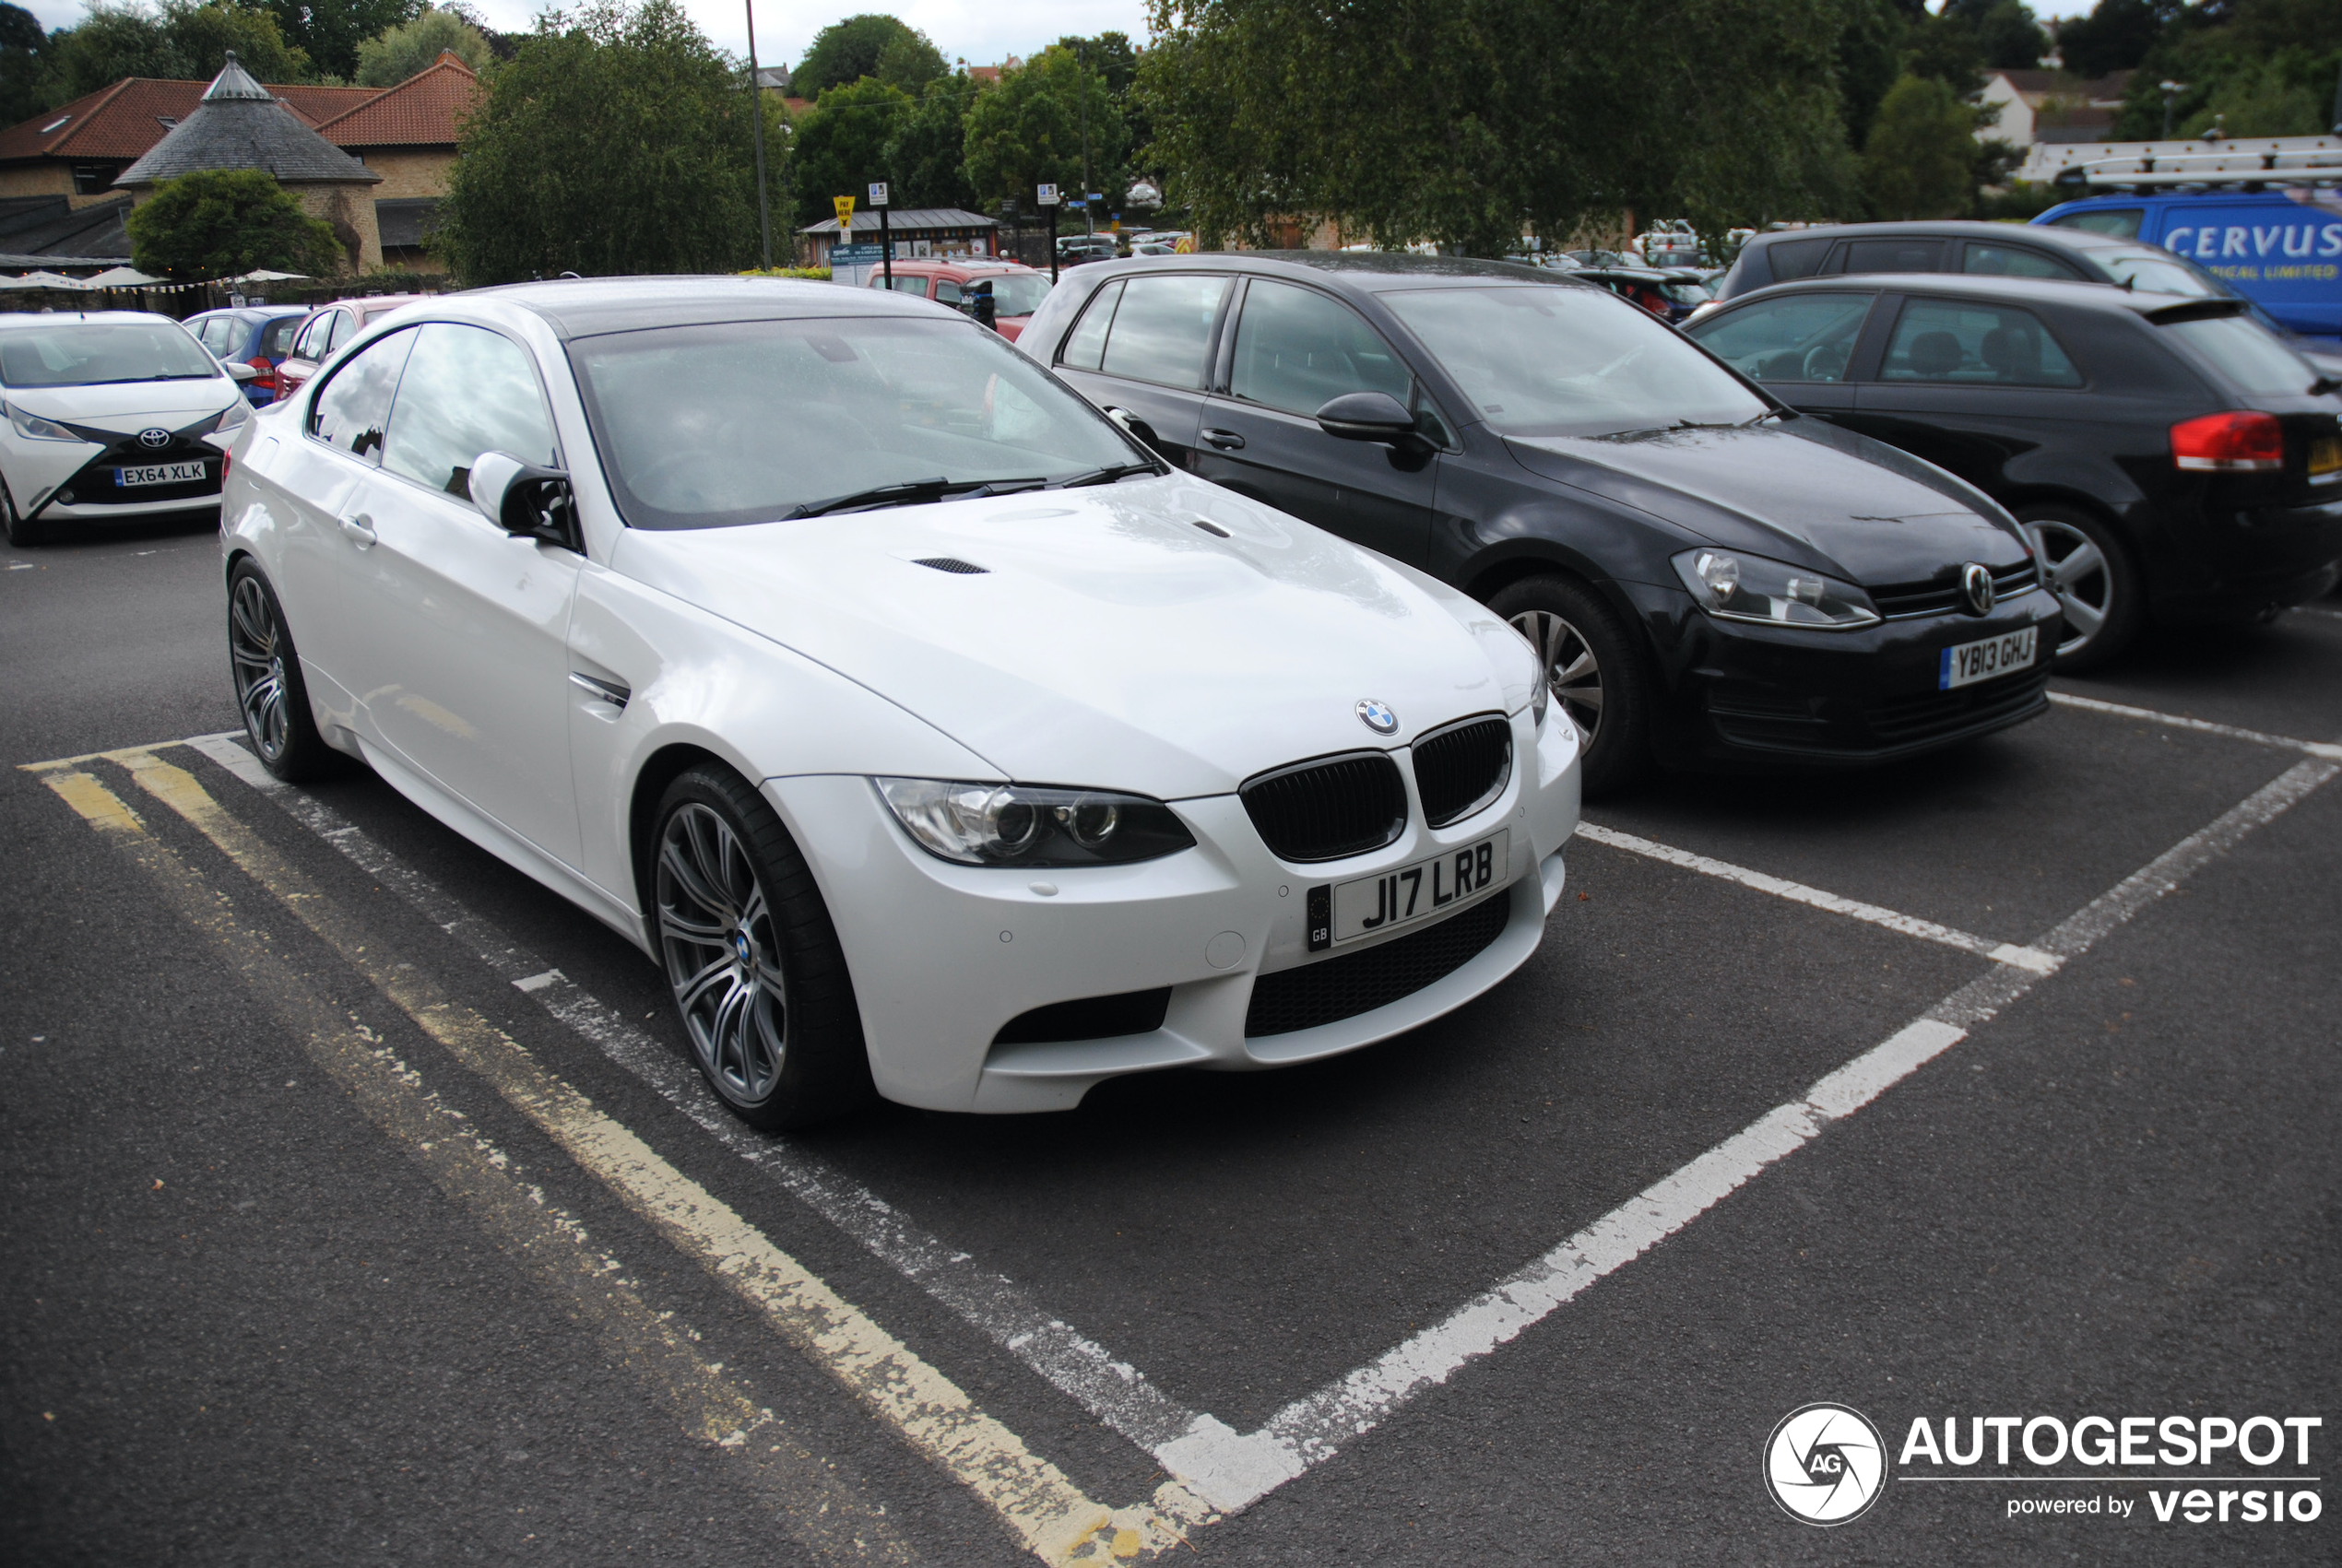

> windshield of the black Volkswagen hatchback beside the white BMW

[{"left": 1382, "top": 283, "right": 1770, "bottom": 435}]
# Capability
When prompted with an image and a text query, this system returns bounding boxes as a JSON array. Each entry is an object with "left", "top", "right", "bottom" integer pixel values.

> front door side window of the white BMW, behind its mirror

[{"left": 388, "top": 321, "right": 560, "bottom": 496}]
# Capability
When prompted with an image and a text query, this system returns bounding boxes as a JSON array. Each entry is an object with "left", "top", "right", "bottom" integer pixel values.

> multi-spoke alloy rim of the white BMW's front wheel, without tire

[{"left": 658, "top": 800, "right": 789, "bottom": 1104}]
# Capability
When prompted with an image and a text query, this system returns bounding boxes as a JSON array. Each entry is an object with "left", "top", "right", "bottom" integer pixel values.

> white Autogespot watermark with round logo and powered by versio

[{"left": 1764, "top": 1404, "right": 2325, "bottom": 1526}]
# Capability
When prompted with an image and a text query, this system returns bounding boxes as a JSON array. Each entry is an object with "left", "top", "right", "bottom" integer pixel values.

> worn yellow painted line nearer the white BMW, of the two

[{"left": 68, "top": 751, "right": 1209, "bottom": 1563}]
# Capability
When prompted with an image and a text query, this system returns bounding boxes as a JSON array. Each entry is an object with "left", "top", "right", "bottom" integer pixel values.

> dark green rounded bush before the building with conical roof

[{"left": 122, "top": 169, "right": 342, "bottom": 283}]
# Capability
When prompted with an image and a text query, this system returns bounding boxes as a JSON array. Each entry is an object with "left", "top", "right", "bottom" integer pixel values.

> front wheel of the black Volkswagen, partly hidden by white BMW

[{"left": 1487, "top": 578, "right": 1653, "bottom": 796}]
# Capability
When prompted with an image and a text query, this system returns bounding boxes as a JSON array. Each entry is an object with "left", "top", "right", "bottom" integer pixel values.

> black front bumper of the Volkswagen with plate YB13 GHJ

[{"left": 1639, "top": 587, "right": 2064, "bottom": 768}]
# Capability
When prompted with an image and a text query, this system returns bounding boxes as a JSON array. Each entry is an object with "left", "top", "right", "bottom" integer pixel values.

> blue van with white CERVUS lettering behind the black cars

[{"left": 2033, "top": 185, "right": 2342, "bottom": 348}]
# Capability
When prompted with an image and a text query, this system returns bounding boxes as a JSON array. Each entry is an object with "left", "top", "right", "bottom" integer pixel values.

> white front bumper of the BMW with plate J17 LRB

[{"left": 766, "top": 712, "right": 1579, "bottom": 1112}]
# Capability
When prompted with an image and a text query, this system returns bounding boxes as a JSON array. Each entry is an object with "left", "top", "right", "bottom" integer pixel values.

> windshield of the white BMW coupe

[{"left": 569, "top": 316, "right": 1153, "bottom": 529}]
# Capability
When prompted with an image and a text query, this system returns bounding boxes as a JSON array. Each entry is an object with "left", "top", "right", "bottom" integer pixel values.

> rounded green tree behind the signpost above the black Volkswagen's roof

[{"left": 964, "top": 44, "right": 1129, "bottom": 208}]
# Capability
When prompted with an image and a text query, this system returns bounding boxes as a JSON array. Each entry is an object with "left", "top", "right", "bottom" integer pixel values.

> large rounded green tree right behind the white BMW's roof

[{"left": 438, "top": 0, "right": 762, "bottom": 283}]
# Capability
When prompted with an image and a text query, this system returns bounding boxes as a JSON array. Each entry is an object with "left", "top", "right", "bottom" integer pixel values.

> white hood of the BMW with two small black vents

[{"left": 611, "top": 475, "right": 1536, "bottom": 798}]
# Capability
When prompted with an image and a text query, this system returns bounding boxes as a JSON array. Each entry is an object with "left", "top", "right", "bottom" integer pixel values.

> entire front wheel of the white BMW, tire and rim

[{"left": 645, "top": 763, "right": 876, "bottom": 1133}]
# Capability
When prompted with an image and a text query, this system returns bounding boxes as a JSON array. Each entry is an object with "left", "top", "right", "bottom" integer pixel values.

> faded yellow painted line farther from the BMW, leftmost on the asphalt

[{"left": 44, "top": 770, "right": 918, "bottom": 1563}]
